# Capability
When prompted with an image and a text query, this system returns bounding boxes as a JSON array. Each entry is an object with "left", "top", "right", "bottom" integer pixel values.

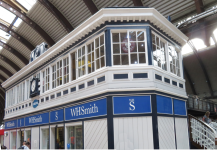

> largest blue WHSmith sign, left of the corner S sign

[{"left": 65, "top": 99, "right": 107, "bottom": 120}]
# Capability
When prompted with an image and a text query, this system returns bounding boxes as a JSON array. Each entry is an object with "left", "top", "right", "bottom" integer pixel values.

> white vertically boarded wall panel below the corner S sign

[{"left": 114, "top": 117, "right": 154, "bottom": 150}]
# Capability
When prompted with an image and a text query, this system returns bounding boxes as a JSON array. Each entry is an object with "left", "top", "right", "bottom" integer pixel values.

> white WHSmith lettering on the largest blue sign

[{"left": 70, "top": 104, "right": 98, "bottom": 117}]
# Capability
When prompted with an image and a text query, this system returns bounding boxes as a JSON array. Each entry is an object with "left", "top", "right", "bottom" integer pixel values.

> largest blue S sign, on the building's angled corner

[{"left": 113, "top": 96, "right": 151, "bottom": 114}]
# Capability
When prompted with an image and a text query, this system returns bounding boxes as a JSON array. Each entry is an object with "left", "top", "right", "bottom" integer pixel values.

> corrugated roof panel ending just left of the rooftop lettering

[{"left": 7, "top": 37, "right": 31, "bottom": 59}]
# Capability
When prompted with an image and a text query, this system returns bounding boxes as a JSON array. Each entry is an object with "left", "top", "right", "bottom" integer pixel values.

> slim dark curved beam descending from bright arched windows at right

[{"left": 188, "top": 41, "right": 214, "bottom": 97}]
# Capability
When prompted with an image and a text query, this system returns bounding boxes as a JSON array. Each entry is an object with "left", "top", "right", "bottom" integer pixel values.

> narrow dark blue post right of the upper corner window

[{"left": 146, "top": 27, "right": 153, "bottom": 65}]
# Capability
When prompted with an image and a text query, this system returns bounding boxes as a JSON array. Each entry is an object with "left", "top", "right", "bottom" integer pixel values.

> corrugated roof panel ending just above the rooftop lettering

[{"left": 16, "top": 22, "right": 45, "bottom": 46}]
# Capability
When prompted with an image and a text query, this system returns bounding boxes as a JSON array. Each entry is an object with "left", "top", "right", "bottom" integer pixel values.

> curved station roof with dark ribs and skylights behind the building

[{"left": 0, "top": 0, "right": 217, "bottom": 122}]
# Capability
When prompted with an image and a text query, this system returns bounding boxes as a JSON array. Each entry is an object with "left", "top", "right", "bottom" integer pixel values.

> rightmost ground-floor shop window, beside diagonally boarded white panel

[{"left": 66, "top": 126, "right": 83, "bottom": 149}]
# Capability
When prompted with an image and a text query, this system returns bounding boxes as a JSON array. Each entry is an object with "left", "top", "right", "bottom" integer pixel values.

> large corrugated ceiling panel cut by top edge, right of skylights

[{"left": 49, "top": 0, "right": 91, "bottom": 28}]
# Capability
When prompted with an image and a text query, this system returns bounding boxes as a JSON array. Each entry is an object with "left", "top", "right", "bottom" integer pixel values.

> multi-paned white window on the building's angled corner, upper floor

[{"left": 112, "top": 31, "right": 146, "bottom": 65}]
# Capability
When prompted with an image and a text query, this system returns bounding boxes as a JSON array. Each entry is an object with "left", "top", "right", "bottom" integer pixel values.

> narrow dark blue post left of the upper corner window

[{"left": 105, "top": 29, "right": 112, "bottom": 66}]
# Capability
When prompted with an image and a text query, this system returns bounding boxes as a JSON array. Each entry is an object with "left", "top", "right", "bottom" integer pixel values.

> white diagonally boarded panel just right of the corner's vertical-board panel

[{"left": 157, "top": 117, "right": 176, "bottom": 149}]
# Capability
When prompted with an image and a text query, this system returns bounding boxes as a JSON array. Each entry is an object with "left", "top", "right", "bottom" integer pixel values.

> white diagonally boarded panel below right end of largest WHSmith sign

[{"left": 84, "top": 119, "right": 108, "bottom": 149}]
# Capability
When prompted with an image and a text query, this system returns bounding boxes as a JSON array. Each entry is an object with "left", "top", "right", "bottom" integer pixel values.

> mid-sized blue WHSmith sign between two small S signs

[{"left": 25, "top": 113, "right": 49, "bottom": 126}]
